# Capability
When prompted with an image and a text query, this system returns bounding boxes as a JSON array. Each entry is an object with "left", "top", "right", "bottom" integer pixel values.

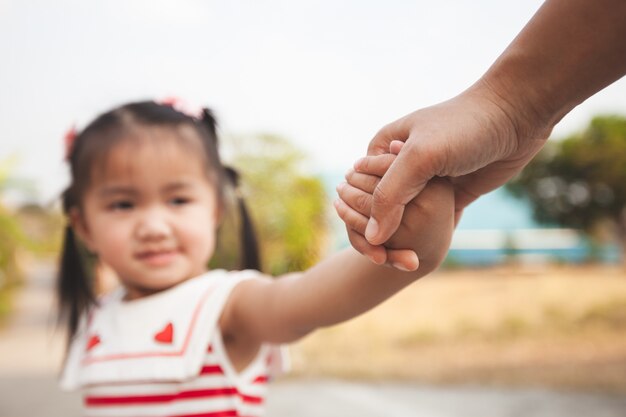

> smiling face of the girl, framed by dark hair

[{"left": 72, "top": 129, "right": 218, "bottom": 299}]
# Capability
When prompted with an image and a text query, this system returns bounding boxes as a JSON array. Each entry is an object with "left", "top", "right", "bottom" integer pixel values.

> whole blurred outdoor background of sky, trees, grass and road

[{"left": 0, "top": 0, "right": 626, "bottom": 417}]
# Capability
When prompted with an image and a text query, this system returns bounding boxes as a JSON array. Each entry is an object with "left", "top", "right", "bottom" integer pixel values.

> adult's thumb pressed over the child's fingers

[{"left": 365, "top": 145, "right": 430, "bottom": 245}]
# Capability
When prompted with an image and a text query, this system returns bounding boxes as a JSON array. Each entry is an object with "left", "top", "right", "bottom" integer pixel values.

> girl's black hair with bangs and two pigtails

[{"left": 57, "top": 101, "right": 261, "bottom": 341}]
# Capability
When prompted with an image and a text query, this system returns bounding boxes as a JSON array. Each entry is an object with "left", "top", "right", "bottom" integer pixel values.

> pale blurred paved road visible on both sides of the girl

[{"left": 0, "top": 269, "right": 626, "bottom": 417}]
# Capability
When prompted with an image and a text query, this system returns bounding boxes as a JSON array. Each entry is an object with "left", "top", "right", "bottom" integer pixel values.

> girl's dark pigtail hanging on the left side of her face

[{"left": 57, "top": 191, "right": 96, "bottom": 341}]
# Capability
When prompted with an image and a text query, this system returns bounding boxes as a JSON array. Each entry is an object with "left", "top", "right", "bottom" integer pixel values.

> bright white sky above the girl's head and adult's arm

[{"left": 0, "top": 0, "right": 626, "bottom": 200}]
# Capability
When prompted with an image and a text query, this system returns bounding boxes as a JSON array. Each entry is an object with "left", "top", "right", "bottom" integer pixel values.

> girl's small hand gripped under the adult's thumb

[{"left": 335, "top": 144, "right": 454, "bottom": 271}]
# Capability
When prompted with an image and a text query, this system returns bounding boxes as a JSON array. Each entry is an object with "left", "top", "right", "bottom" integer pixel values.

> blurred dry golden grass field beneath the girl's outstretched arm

[{"left": 291, "top": 266, "right": 626, "bottom": 393}]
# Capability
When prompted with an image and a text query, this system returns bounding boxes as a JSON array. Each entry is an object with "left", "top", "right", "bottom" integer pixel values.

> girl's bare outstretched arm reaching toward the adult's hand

[{"left": 220, "top": 161, "right": 454, "bottom": 343}]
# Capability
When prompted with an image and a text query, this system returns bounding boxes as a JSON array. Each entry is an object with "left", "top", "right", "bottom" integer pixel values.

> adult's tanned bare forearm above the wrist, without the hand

[{"left": 477, "top": 0, "right": 626, "bottom": 139}]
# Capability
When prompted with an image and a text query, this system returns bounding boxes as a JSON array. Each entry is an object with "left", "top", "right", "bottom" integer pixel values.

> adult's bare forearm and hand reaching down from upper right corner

[{"left": 338, "top": 0, "right": 626, "bottom": 266}]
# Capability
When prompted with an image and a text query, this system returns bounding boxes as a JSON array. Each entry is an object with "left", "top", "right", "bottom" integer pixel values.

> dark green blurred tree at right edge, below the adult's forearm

[{"left": 507, "top": 116, "right": 626, "bottom": 263}]
